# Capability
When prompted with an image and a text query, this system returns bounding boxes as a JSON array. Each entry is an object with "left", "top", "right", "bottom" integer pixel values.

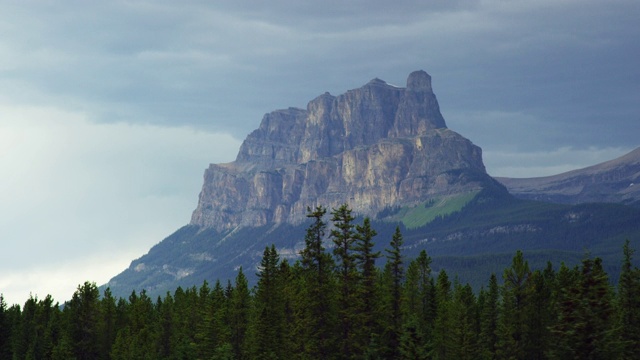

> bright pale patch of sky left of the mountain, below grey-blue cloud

[{"left": 0, "top": 105, "right": 239, "bottom": 300}]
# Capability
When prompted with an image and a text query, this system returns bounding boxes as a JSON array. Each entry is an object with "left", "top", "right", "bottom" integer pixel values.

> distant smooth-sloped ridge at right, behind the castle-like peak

[{"left": 496, "top": 148, "right": 640, "bottom": 206}]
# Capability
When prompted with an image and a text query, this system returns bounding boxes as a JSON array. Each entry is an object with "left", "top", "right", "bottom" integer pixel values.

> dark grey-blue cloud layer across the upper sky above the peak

[{"left": 4, "top": 1, "right": 640, "bottom": 149}]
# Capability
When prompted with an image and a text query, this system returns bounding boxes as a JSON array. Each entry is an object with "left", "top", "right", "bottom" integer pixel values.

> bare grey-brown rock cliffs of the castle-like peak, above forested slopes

[{"left": 191, "top": 71, "right": 488, "bottom": 230}]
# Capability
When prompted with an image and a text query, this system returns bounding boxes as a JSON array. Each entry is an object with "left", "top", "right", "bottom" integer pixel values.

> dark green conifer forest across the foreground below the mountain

[{"left": 0, "top": 205, "right": 640, "bottom": 360}]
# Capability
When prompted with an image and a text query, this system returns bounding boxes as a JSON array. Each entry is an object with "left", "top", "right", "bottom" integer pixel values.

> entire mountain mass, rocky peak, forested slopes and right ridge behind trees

[{"left": 105, "top": 71, "right": 640, "bottom": 297}]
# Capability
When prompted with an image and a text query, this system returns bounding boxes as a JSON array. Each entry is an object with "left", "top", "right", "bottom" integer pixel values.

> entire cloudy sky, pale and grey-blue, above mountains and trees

[{"left": 0, "top": 0, "right": 640, "bottom": 304}]
